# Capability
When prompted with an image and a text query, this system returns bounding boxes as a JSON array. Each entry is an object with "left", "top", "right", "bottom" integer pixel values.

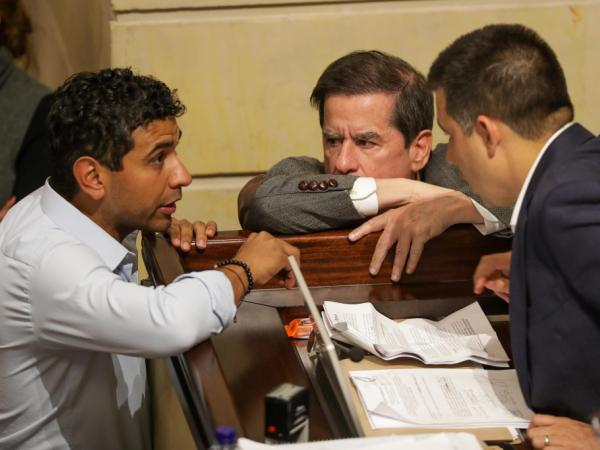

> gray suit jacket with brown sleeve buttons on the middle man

[{"left": 241, "top": 145, "right": 512, "bottom": 234}]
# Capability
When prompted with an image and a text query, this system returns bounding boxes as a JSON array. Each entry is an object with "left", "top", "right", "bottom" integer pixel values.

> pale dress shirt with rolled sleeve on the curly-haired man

[{"left": 0, "top": 182, "right": 235, "bottom": 450}]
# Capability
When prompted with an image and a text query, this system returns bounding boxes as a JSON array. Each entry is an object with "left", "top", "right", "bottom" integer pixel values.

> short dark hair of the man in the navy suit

[{"left": 428, "top": 24, "right": 573, "bottom": 139}]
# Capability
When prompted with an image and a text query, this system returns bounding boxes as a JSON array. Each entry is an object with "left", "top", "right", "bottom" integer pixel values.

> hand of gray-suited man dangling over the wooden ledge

[{"left": 348, "top": 193, "right": 462, "bottom": 281}]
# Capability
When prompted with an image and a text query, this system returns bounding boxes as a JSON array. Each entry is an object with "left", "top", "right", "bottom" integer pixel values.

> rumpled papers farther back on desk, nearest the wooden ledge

[{"left": 323, "top": 301, "right": 509, "bottom": 367}]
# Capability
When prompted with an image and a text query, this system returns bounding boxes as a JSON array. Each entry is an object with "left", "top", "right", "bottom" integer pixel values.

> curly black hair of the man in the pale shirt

[{"left": 48, "top": 69, "right": 185, "bottom": 199}]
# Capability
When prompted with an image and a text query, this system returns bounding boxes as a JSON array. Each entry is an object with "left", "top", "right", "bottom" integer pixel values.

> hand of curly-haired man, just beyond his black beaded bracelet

[{"left": 235, "top": 231, "right": 300, "bottom": 289}]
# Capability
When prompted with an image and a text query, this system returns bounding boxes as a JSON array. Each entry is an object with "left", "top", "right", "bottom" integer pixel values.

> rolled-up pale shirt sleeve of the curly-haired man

[{"left": 30, "top": 244, "right": 236, "bottom": 357}]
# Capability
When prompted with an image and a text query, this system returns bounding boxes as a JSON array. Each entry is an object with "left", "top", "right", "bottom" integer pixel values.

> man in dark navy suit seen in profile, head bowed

[{"left": 428, "top": 25, "right": 600, "bottom": 449}]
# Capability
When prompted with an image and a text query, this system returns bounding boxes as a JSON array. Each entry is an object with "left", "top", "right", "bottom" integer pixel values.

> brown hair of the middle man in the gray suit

[{"left": 310, "top": 50, "right": 433, "bottom": 144}]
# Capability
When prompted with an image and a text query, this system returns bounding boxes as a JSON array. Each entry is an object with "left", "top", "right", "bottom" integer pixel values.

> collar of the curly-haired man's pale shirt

[{"left": 41, "top": 180, "right": 128, "bottom": 271}]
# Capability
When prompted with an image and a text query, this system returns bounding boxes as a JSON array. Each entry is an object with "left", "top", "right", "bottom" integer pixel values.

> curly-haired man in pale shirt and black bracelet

[{"left": 0, "top": 69, "right": 298, "bottom": 450}]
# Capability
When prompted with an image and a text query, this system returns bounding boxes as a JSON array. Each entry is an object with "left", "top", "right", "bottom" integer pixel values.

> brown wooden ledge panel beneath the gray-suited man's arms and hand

[{"left": 173, "top": 225, "right": 511, "bottom": 287}]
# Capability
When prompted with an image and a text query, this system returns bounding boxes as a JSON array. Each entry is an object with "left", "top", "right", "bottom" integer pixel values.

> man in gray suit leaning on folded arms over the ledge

[{"left": 238, "top": 51, "right": 512, "bottom": 281}]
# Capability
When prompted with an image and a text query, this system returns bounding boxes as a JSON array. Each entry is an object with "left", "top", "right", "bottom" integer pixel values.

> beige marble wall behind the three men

[{"left": 111, "top": 0, "right": 600, "bottom": 229}]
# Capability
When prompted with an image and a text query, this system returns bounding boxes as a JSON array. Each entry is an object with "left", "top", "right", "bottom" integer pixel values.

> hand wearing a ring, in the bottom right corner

[{"left": 527, "top": 414, "right": 600, "bottom": 450}]
